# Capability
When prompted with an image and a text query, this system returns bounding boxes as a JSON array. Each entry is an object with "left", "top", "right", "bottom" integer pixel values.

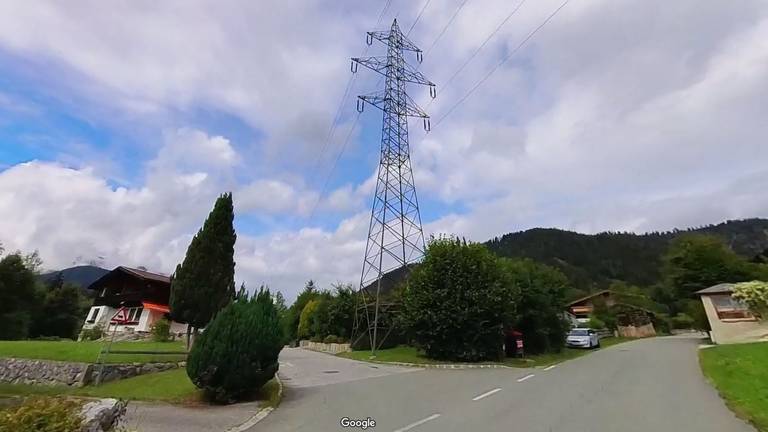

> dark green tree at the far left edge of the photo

[{"left": 0, "top": 254, "right": 42, "bottom": 340}]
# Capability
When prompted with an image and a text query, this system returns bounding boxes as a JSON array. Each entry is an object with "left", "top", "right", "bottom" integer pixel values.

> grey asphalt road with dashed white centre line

[{"left": 251, "top": 337, "right": 754, "bottom": 432}]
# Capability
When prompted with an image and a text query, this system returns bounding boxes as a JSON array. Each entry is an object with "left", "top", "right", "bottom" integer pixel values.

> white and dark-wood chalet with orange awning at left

[{"left": 83, "top": 266, "right": 186, "bottom": 333}]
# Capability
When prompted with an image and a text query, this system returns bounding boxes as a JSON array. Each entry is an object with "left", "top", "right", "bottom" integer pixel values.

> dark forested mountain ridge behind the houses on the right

[{"left": 486, "top": 219, "right": 768, "bottom": 290}]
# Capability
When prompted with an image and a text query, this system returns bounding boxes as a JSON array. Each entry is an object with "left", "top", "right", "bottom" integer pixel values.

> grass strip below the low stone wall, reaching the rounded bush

[{"left": 0, "top": 368, "right": 280, "bottom": 407}]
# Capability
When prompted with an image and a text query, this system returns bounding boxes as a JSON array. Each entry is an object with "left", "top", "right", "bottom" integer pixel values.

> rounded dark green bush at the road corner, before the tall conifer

[{"left": 187, "top": 288, "right": 283, "bottom": 402}]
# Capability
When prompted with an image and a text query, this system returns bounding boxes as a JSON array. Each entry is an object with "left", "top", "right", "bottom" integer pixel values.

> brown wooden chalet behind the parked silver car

[{"left": 566, "top": 290, "right": 656, "bottom": 337}]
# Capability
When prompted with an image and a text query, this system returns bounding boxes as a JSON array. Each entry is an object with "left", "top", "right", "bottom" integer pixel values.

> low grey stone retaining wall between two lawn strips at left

[{"left": 0, "top": 358, "right": 186, "bottom": 387}]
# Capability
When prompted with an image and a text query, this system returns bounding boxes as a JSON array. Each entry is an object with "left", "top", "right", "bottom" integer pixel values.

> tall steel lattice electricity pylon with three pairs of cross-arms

[{"left": 352, "top": 19, "right": 435, "bottom": 352}]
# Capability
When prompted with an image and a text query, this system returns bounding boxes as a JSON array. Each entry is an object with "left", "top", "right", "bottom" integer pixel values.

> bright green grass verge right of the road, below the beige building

[{"left": 699, "top": 342, "right": 768, "bottom": 432}]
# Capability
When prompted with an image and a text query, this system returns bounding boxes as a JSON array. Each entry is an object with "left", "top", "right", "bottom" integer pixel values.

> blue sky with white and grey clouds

[{"left": 0, "top": 0, "right": 768, "bottom": 300}]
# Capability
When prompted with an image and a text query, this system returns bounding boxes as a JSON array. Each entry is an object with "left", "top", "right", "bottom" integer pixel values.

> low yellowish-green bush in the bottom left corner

[{"left": 0, "top": 397, "right": 83, "bottom": 432}]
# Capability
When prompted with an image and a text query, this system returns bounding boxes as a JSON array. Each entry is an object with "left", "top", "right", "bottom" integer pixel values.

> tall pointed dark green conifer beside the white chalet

[{"left": 170, "top": 193, "right": 237, "bottom": 328}]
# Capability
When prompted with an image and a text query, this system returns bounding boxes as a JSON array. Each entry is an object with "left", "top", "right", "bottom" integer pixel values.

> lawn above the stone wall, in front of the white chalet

[{"left": 0, "top": 341, "right": 186, "bottom": 363}]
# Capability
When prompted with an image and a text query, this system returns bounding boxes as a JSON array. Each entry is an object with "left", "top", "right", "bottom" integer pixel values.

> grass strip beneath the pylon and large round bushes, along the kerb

[{"left": 338, "top": 337, "right": 632, "bottom": 367}]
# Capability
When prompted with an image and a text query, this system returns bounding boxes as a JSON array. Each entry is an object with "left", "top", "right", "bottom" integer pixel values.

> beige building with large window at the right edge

[{"left": 696, "top": 283, "right": 768, "bottom": 344}]
